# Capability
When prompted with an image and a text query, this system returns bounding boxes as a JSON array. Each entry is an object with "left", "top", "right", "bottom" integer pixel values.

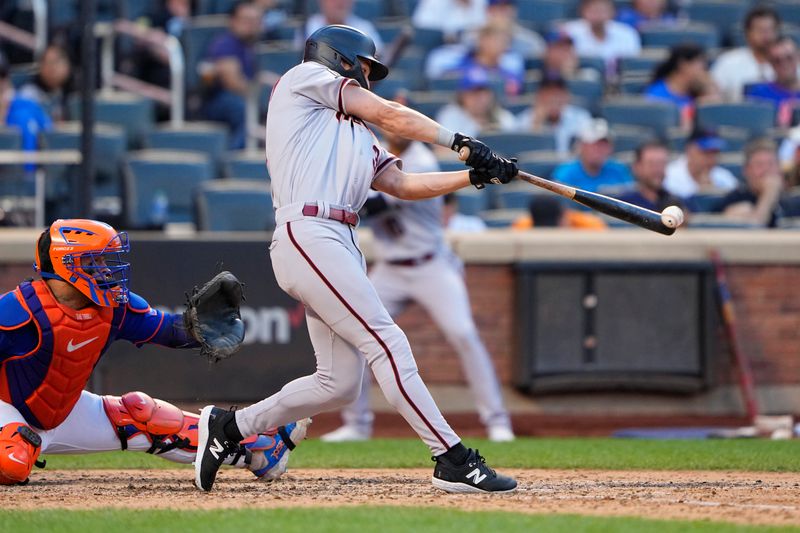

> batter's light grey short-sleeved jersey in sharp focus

[{"left": 267, "top": 62, "right": 399, "bottom": 211}]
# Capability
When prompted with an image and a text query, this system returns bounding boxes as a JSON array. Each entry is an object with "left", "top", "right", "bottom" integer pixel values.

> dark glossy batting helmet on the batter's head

[{"left": 303, "top": 24, "right": 389, "bottom": 89}]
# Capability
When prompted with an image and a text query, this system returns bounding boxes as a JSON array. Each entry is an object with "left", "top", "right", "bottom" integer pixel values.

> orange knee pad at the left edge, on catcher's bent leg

[{"left": 0, "top": 422, "right": 44, "bottom": 485}]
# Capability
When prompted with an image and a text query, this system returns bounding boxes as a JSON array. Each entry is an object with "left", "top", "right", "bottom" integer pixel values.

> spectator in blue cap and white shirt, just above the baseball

[{"left": 664, "top": 128, "right": 739, "bottom": 199}]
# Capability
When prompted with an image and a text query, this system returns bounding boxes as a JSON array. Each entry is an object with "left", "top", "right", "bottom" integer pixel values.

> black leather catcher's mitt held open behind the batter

[{"left": 183, "top": 270, "right": 244, "bottom": 362}]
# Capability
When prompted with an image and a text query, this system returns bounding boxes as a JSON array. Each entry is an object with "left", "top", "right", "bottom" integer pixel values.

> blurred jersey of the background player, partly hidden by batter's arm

[{"left": 370, "top": 141, "right": 447, "bottom": 261}]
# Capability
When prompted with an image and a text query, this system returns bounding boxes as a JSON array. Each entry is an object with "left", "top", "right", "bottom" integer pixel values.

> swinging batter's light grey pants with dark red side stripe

[{"left": 236, "top": 218, "right": 460, "bottom": 455}]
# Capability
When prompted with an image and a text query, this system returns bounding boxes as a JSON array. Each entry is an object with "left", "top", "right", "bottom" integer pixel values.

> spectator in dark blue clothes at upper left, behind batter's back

[{"left": 205, "top": 1, "right": 261, "bottom": 150}]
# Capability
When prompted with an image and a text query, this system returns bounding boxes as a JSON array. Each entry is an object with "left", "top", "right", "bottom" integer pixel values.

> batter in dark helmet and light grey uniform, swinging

[{"left": 195, "top": 26, "right": 517, "bottom": 492}]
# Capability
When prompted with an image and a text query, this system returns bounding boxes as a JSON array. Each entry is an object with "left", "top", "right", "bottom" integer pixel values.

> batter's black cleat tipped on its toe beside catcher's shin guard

[{"left": 194, "top": 405, "right": 239, "bottom": 491}]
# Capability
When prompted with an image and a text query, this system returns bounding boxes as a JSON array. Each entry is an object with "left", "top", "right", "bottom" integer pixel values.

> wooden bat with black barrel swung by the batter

[{"left": 458, "top": 147, "right": 676, "bottom": 235}]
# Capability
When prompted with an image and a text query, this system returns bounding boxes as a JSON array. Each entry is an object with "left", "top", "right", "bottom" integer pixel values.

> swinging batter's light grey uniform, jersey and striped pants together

[{"left": 231, "top": 62, "right": 460, "bottom": 455}]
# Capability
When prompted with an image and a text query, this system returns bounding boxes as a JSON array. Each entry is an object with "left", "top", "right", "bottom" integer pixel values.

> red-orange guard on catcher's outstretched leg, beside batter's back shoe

[{"left": 103, "top": 392, "right": 197, "bottom": 453}]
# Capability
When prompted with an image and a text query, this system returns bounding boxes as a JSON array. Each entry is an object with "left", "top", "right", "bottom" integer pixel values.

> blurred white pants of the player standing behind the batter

[{"left": 342, "top": 252, "right": 511, "bottom": 433}]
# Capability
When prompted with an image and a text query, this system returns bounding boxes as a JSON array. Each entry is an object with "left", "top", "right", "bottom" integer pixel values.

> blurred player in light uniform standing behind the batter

[{"left": 322, "top": 133, "right": 514, "bottom": 442}]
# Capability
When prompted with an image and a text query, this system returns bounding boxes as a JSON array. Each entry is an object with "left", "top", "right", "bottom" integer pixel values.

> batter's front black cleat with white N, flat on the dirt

[{"left": 432, "top": 449, "right": 517, "bottom": 494}]
